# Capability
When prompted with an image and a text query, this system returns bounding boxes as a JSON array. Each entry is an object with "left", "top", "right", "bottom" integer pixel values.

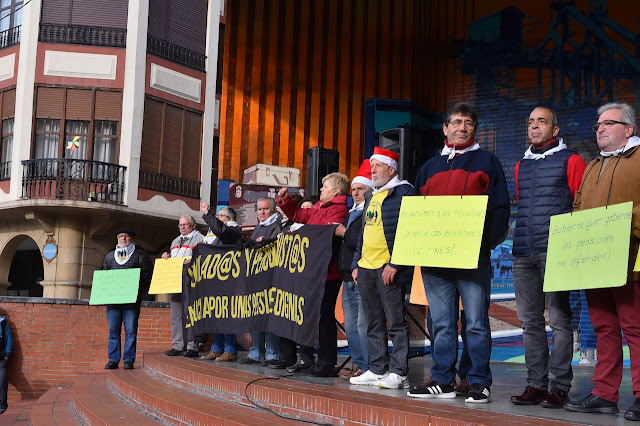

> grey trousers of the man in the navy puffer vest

[{"left": 513, "top": 253, "right": 573, "bottom": 392}]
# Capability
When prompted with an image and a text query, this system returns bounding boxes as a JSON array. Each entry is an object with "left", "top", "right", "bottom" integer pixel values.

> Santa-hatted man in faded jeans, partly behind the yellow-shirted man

[{"left": 336, "top": 160, "right": 374, "bottom": 378}]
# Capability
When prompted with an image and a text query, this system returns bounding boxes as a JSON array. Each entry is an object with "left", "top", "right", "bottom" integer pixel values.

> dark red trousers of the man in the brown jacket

[{"left": 585, "top": 283, "right": 640, "bottom": 403}]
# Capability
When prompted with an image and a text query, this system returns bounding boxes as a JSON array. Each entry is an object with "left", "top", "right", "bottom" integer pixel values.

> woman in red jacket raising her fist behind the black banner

[{"left": 273, "top": 173, "right": 351, "bottom": 377}]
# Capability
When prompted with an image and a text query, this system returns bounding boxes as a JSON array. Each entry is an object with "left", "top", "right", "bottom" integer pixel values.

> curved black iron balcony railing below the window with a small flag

[{"left": 22, "top": 158, "right": 127, "bottom": 204}]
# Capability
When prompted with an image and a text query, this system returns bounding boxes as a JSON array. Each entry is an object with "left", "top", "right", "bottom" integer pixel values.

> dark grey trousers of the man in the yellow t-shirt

[{"left": 358, "top": 268, "right": 409, "bottom": 376}]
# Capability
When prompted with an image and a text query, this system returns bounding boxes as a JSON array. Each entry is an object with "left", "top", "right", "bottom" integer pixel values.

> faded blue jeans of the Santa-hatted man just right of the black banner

[{"left": 342, "top": 281, "right": 369, "bottom": 371}]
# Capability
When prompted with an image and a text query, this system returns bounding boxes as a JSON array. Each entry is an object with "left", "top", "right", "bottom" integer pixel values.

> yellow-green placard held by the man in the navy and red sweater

[{"left": 391, "top": 195, "right": 489, "bottom": 269}]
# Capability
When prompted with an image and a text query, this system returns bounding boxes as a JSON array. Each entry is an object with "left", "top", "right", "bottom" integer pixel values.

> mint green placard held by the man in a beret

[{"left": 89, "top": 268, "right": 140, "bottom": 305}]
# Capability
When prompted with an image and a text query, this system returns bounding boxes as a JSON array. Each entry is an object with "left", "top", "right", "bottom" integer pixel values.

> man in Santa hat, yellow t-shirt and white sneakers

[{"left": 349, "top": 147, "right": 414, "bottom": 389}]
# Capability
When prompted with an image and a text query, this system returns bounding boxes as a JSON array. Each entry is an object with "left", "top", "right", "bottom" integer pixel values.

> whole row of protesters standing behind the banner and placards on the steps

[{"left": 104, "top": 103, "right": 640, "bottom": 420}]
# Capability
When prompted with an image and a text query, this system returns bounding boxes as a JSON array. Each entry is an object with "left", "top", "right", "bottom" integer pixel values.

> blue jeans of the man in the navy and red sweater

[{"left": 422, "top": 251, "right": 492, "bottom": 386}]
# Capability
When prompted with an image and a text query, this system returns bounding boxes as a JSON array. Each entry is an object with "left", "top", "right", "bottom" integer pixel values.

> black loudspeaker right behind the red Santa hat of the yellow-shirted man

[{"left": 378, "top": 127, "right": 442, "bottom": 183}]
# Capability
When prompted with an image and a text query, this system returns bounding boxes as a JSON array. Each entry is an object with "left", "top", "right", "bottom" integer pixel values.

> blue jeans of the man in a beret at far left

[{"left": 107, "top": 304, "right": 140, "bottom": 363}]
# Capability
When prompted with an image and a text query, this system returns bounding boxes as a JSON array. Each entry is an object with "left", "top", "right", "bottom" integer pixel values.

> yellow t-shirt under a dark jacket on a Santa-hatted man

[{"left": 358, "top": 190, "right": 391, "bottom": 269}]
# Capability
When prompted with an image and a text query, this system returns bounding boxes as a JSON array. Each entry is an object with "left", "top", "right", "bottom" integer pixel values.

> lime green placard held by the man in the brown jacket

[{"left": 544, "top": 202, "right": 633, "bottom": 292}]
